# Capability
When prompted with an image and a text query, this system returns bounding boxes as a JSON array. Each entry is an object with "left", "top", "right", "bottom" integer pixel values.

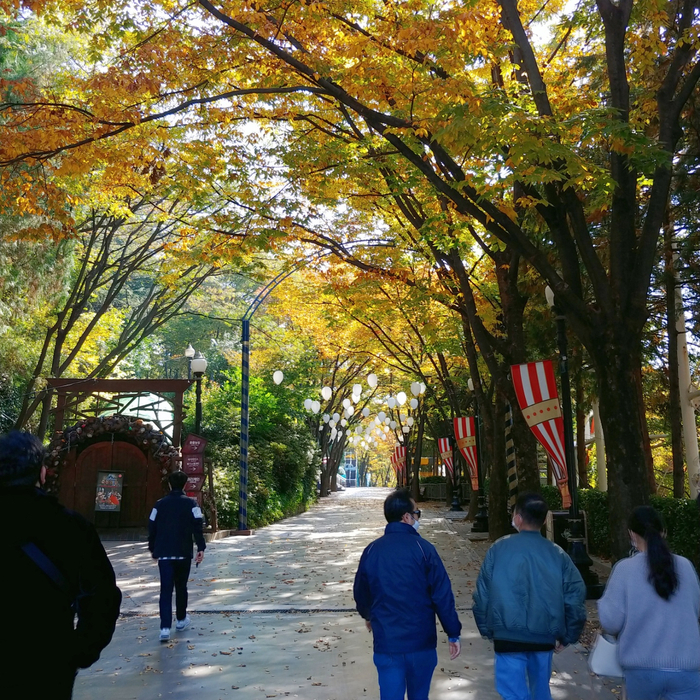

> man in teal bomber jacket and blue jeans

[{"left": 473, "top": 493, "right": 586, "bottom": 700}]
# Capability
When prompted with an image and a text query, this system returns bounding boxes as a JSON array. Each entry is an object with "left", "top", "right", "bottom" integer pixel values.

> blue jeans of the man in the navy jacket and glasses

[{"left": 374, "top": 649, "right": 437, "bottom": 700}]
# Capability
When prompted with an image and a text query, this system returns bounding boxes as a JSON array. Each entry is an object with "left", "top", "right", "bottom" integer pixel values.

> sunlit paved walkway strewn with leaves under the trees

[{"left": 74, "top": 489, "right": 618, "bottom": 700}]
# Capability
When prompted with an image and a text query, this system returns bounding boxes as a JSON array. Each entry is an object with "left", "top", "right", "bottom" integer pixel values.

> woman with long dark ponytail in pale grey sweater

[{"left": 598, "top": 506, "right": 700, "bottom": 700}]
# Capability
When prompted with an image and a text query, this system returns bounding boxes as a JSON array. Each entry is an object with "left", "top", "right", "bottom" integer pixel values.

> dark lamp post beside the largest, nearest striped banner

[{"left": 545, "top": 287, "right": 603, "bottom": 599}]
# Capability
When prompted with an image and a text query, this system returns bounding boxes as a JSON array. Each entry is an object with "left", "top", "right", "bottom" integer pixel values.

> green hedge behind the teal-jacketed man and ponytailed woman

[{"left": 542, "top": 486, "right": 700, "bottom": 568}]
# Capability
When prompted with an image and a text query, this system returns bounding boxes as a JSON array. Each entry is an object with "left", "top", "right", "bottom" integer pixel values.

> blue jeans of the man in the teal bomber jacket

[{"left": 496, "top": 651, "right": 554, "bottom": 700}]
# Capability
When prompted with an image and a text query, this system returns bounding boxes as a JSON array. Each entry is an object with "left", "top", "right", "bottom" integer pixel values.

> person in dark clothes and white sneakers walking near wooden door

[{"left": 148, "top": 472, "right": 207, "bottom": 642}]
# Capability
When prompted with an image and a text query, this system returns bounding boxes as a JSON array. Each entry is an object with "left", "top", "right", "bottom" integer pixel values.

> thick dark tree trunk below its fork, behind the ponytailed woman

[{"left": 592, "top": 348, "right": 649, "bottom": 560}]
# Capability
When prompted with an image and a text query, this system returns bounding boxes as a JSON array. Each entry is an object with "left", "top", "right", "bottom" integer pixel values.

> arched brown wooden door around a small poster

[{"left": 73, "top": 440, "right": 148, "bottom": 527}]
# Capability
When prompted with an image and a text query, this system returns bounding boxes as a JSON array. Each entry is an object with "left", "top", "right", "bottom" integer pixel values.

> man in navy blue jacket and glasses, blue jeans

[{"left": 353, "top": 490, "right": 462, "bottom": 700}]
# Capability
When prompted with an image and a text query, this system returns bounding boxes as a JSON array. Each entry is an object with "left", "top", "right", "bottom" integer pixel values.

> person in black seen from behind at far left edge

[{"left": 0, "top": 432, "right": 121, "bottom": 700}]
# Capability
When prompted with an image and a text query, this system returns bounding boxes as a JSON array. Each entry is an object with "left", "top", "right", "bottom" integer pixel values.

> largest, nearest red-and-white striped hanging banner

[{"left": 510, "top": 360, "right": 571, "bottom": 508}]
